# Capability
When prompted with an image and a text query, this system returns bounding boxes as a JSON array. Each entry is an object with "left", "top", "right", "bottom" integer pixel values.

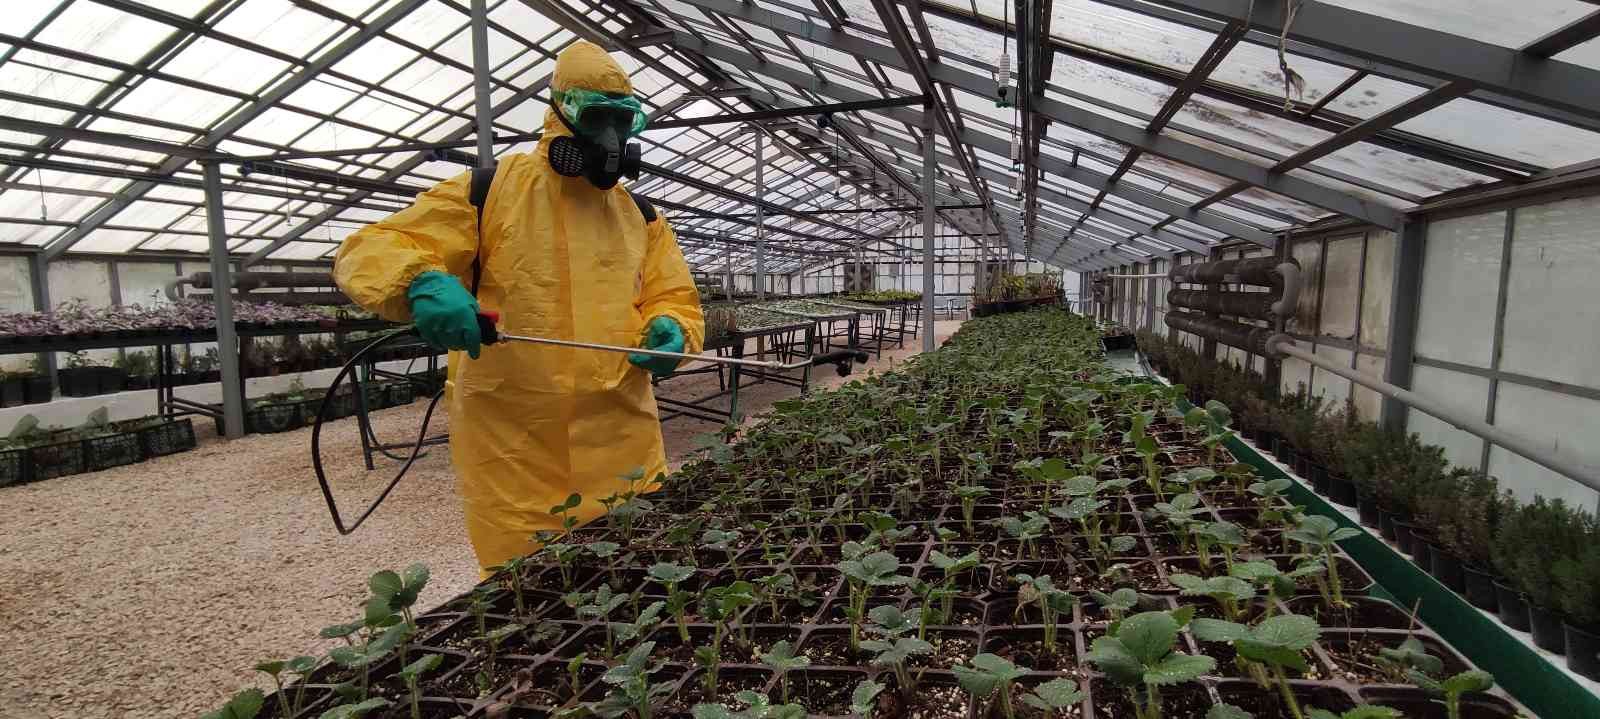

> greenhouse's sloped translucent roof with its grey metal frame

[{"left": 0, "top": 0, "right": 1600, "bottom": 435}]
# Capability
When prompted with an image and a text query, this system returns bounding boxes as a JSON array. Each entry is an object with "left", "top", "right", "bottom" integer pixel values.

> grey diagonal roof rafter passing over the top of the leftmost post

[{"left": 42, "top": 0, "right": 427, "bottom": 263}]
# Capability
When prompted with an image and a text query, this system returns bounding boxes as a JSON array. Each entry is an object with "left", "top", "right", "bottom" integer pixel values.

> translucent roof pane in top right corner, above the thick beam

[{"left": 1328, "top": 0, "right": 1594, "bottom": 48}]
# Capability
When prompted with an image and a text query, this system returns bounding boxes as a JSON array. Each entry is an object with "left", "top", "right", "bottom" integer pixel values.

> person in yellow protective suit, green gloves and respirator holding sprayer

[{"left": 334, "top": 42, "right": 706, "bottom": 570}]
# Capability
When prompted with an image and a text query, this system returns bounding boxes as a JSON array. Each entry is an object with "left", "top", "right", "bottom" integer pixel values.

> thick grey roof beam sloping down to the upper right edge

[{"left": 1132, "top": 0, "right": 1600, "bottom": 118}]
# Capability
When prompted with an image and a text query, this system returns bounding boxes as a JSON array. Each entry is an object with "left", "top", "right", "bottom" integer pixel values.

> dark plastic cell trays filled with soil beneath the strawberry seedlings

[{"left": 252, "top": 312, "right": 1515, "bottom": 719}]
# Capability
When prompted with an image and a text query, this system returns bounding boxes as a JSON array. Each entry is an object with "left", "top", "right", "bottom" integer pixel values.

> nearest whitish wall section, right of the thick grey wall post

[{"left": 1406, "top": 195, "right": 1600, "bottom": 509}]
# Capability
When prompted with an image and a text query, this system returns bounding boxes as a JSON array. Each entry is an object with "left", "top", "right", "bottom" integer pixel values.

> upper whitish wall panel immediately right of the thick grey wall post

[{"left": 1416, "top": 211, "right": 1506, "bottom": 367}]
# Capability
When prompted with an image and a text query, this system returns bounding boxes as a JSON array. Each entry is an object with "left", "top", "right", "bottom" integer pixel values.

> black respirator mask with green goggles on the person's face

[{"left": 549, "top": 88, "right": 645, "bottom": 189}]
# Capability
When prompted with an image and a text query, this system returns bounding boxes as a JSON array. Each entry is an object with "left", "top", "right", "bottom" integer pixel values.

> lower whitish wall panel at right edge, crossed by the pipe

[{"left": 1490, "top": 381, "right": 1600, "bottom": 512}]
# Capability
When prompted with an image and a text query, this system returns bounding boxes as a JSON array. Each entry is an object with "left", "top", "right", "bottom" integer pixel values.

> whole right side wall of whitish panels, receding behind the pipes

[{"left": 1107, "top": 184, "right": 1600, "bottom": 509}]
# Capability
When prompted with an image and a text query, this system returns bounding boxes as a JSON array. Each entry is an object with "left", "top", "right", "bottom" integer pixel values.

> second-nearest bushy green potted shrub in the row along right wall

[{"left": 1494, "top": 496, "right": 1594, "bottom": 653}]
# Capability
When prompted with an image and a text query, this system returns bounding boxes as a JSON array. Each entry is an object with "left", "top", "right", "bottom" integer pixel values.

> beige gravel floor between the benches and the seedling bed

[{"left": 0, "top": 320, "right": 960, "bottom": 719}]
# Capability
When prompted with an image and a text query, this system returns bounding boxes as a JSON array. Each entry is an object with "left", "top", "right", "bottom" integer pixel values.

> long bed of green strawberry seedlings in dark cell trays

[{"left": 256, "top": 312, "right": 1514, "bottom": 719}]
